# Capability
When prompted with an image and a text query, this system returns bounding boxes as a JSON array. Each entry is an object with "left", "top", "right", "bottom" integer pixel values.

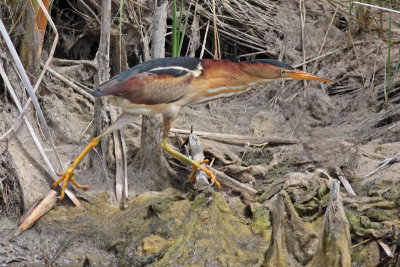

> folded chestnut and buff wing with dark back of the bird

[{"left": 93, "top": 58, "right": 202, "bottom": 105}]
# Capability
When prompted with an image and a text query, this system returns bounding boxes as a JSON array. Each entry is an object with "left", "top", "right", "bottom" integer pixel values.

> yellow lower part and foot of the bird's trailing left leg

[{"left": 51, "top": 136, "right": 101, "bottom": 200}]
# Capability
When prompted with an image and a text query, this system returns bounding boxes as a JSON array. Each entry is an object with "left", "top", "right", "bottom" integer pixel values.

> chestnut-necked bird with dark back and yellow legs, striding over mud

[{"left": 52, "top": 57, "right": 333, "bottom": 199}]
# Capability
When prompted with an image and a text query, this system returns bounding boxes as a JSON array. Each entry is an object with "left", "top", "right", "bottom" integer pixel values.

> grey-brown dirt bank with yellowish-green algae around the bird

[{"left": 0, "top": 1, "right": 400, "bottom": 266}]
